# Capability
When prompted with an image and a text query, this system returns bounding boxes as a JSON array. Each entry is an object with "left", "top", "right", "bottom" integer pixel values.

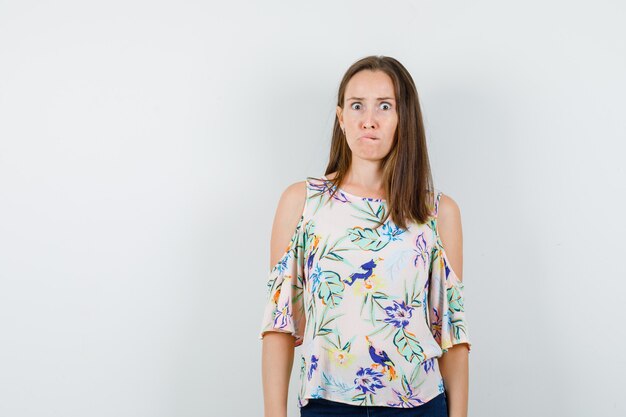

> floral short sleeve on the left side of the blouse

[{"left": 259, "top": 216, "right": 306, "bottom": 346}]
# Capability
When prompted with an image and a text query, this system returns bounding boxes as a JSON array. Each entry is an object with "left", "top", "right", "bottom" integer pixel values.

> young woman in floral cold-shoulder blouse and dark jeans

[{"left": 260, "top": 56, "right": 471, "bottom": 417}]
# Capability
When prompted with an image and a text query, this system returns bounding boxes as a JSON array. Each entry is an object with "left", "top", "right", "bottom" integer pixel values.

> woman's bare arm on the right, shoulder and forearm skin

[{"left": 437, "top": 194, "right": 469, "bottom": 417}]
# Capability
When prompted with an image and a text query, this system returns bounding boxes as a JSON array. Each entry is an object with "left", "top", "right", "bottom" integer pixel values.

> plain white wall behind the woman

[{"left": 0, "top": 0, "right": 626, "bottom": 417}]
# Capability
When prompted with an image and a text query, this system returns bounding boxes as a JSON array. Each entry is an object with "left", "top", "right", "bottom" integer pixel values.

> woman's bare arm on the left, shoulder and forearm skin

[{"left": 261, "top": 181, "right": 306, "bottom": 417}]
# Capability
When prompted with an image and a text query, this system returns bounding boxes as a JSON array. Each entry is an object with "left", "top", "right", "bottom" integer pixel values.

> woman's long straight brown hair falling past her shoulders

[{"left": 325, "top": 55, "right": 434, "bottom": 228}]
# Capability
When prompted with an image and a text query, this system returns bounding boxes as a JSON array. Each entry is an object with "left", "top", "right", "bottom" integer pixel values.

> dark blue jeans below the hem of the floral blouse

[{"left": 300, "top": 392, "right": 448, "bottom": 417}]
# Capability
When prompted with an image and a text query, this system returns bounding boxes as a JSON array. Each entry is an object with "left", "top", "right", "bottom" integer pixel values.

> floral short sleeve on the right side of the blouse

[{"left": 428, "top": 192, "right": 471, "bottom": 353}]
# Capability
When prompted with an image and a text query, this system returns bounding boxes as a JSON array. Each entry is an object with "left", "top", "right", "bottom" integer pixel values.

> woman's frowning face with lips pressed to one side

[{"left": 337, "top": 70, "right": 398, "bottom": 160}]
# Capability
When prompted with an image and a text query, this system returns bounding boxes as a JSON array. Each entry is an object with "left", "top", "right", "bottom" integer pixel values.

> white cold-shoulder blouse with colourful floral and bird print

[{"left": 260, "top": 176, "right": 471, "bottom": 408}]
